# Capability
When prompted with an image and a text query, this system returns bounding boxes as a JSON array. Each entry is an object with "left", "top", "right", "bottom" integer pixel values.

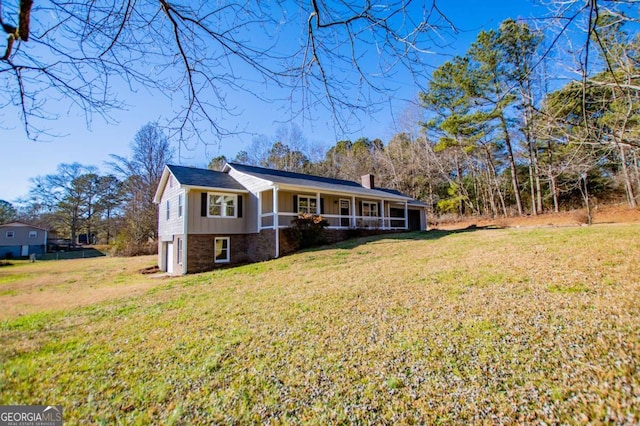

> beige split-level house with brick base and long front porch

[{"left": 154, "top": 163, "right": 427, "bottom": 274}]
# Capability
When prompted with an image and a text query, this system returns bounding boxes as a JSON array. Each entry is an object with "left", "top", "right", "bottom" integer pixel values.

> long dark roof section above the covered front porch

[{"left": 228, "top": 163, "right": 412, "bottom": 201}]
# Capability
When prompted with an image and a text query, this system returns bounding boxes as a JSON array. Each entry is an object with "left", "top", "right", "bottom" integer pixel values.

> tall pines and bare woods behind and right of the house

[{"left": 219, "top": 14, "right": 640, "bottom": 217}]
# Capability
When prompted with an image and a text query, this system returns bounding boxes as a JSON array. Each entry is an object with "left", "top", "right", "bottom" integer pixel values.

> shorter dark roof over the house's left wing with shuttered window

[{"left": 153, "top": 164, "right": 247, "bottom": 203}]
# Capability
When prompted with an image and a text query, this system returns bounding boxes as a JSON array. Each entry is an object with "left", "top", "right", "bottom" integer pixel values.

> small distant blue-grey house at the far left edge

[{"left": 0, "top": 222, "right": 47, "bottom": 259}]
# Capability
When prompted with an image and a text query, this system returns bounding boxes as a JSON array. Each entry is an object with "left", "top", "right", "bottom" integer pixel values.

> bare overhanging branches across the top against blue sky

[{"left": 0, "top": 0, "right": 453, "bottom": 144}]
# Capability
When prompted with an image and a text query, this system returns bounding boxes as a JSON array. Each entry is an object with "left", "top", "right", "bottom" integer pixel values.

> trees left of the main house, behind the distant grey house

[{"left": 0, "top": 123, "right": 173, "bottom": 255}]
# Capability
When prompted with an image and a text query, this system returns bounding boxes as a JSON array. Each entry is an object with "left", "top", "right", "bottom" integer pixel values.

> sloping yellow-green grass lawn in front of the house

[{"left": 0, "top": 224, "right": 640, "bottom": 424}]
